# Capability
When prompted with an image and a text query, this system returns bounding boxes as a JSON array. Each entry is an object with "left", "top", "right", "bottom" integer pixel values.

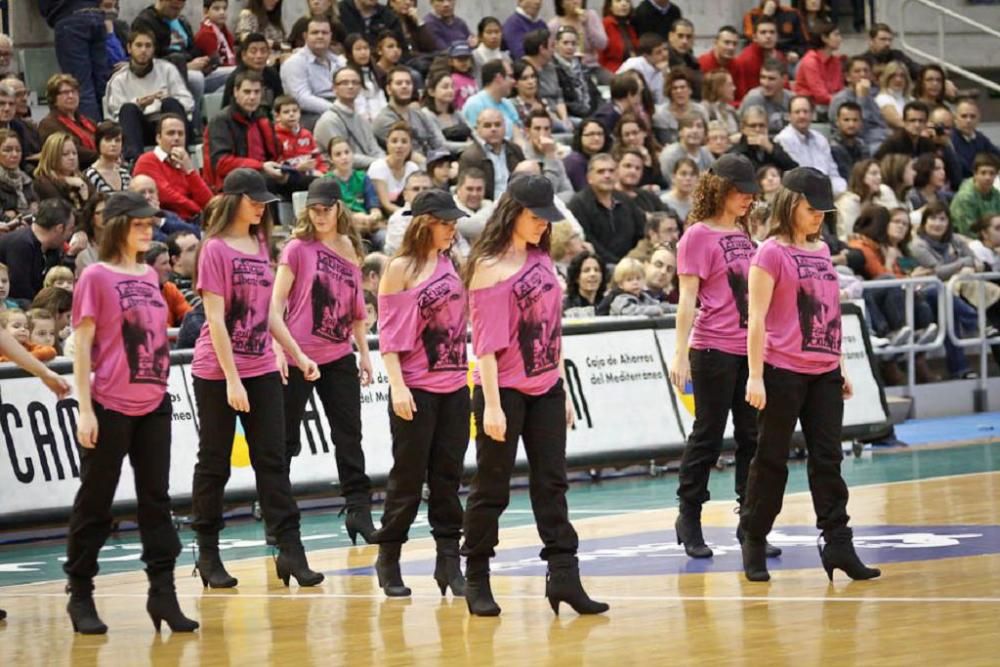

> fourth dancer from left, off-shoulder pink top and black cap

[{"left": 375, "top": 190, "right": 469, "bottom": 597}]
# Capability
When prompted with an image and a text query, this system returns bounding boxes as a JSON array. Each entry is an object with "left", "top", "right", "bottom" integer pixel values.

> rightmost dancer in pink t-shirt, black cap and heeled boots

[{"left": 740, "top": 167, "right": 881, "bottom": 581}]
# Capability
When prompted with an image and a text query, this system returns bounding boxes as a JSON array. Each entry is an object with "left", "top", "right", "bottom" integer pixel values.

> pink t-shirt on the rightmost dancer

[{"left": 753, "top": 238, "right": 841, "bottom": 375}]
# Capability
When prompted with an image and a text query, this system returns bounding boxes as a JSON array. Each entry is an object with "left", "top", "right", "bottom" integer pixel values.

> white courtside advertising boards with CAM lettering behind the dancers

[{"left": 0, "top": 304, "right": 888, "bottom": 525}]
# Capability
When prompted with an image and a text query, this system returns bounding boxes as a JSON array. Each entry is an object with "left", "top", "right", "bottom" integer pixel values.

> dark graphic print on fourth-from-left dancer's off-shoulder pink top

[{"left": 417, "top": 275, "right": 469, "bottom": 373}]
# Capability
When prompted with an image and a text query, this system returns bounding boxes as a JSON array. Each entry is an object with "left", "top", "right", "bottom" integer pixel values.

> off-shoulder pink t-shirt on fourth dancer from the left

[{"left": 378, "top": 255, "right": 469, "bottom": 394}]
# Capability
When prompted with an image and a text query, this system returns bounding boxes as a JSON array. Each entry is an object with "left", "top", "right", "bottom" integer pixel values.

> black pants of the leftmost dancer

[{"left": 63, "top": 396, "right": 181, "bottom": 579}]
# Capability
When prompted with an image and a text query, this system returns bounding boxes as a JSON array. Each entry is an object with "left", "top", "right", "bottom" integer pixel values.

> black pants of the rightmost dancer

[{"left": 742, "top": 364, "right": 850, "bottom": 539}]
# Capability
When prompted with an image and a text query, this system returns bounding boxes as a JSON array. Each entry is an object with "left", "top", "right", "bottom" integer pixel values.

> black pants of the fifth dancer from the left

[{"left": 462, "top": 380, "right": 579, "bottom": 560}]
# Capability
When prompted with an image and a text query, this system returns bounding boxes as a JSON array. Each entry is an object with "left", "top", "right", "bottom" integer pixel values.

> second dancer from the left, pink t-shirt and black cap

[{"left": 191, "top": 169, "right": 323, "bottom": 588}]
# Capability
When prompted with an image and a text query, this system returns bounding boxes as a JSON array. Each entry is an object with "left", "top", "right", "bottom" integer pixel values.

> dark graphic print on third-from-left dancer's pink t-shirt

[{"left": 311, "top": 250, "right": 358, "bottom": 343}]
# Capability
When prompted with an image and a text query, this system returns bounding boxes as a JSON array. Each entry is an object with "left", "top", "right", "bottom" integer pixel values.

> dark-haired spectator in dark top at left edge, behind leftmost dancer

[{"left": 0, "top": 199, "right": 80, "bottom": 301}]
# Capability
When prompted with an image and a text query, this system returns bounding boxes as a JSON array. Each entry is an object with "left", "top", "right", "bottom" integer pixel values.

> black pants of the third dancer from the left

[{"left": 285, "top": 354, "right": 372, "bottom": 505}]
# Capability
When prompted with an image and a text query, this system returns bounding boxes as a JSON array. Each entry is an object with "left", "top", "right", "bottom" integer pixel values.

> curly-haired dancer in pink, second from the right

[{"left": 670, "top": 154, "right": 781, "bottom": 558}]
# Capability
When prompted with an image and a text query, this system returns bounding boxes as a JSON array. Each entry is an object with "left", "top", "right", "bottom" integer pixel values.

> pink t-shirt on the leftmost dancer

[{"left": 73, "top": 264, "right": 170, "bottom": 416}]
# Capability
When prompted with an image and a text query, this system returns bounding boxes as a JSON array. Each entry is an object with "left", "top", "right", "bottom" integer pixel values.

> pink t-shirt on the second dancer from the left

[{"left": 191, "top": 238, "right": 278, "bottom": 380}]
